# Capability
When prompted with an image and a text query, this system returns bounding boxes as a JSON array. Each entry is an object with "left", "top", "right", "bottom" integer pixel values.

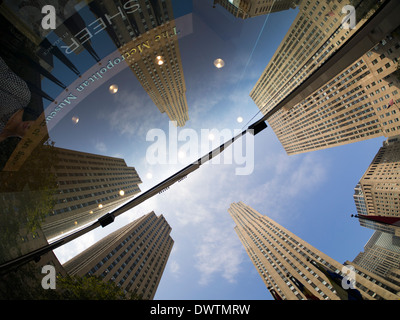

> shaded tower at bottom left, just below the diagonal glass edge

[{"left": 63, "top": 212, "right": 174, "bottom": 300}]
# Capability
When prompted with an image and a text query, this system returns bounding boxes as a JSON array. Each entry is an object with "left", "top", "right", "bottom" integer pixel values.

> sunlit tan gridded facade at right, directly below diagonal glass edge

[{"left": 262, "top": 35, "right": 400, "bottom": 155}]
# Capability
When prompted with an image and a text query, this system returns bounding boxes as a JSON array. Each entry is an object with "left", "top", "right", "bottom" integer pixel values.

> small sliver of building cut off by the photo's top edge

[{"left": 214, "top": 0, "right": 299, "bottom": 19}]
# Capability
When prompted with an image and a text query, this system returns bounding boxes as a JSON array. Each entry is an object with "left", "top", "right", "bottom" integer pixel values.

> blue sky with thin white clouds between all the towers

[{"left": 47, "top": 0, "right": 384, "bottom": 300}]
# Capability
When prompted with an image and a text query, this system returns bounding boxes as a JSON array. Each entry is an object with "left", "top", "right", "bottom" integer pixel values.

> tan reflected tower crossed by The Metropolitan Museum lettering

[{"left": 89, "top": 0, "right": 189, "bottom": 126}]
